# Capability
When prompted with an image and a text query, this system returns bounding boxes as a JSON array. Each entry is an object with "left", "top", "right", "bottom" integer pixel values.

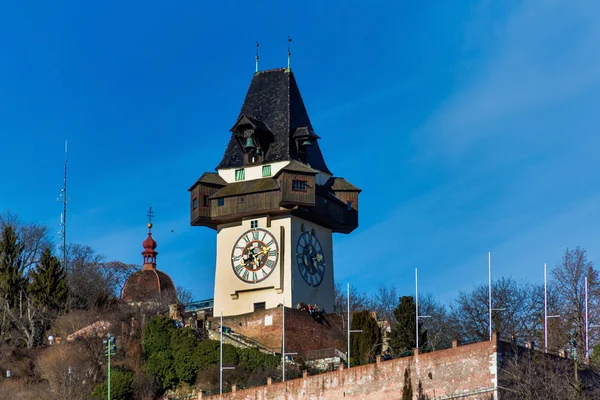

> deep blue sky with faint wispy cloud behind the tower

[{"left": 0, "top": 0, "right": 600, "bottom": 301}]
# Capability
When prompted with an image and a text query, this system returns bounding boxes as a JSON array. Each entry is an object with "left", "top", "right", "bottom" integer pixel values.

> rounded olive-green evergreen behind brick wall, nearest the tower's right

[{"left": 350, "top": 311, "right": 381, "bottom": 364}]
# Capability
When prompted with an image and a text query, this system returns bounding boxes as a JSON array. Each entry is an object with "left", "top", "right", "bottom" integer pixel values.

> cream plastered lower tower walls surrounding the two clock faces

[{"left": 214, "top": 214, "right": 334, "bottom": 315}]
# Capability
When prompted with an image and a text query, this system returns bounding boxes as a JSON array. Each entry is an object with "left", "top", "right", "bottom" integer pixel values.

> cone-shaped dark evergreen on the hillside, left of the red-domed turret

[{"left": 28, "top": 247, "right": 68, "bottom": 311}]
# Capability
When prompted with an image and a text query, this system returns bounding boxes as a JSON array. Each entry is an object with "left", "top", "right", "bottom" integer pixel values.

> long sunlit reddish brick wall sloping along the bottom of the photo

[{"left": 205, "top": 336, "right": 497, "bottom": 400}]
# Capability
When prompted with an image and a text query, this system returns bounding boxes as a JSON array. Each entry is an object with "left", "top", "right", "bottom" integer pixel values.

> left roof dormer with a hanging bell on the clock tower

[{"left": 231, "top": 114, "right": 274, "bottom": 165}]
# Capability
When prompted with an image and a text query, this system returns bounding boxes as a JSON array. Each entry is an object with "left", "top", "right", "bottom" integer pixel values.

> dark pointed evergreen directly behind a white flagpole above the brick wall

[{"left": 390, "top": 296, "right": 427, "bottom": 353}]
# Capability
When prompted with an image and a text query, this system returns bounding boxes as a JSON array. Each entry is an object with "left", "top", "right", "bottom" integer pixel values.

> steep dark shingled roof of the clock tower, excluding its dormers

[{"left": 217, "top": 68, "right": 331, "bottom": 173}]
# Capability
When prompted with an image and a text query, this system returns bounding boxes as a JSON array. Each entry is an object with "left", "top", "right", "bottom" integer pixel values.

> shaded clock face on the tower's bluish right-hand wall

[{"left": 296, "top": 232, "right": 325, "bottom": 287}]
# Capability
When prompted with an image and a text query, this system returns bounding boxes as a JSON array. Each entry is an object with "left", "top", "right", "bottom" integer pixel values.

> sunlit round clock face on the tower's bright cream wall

[{"left": 231, "top": 229, "right": 279, "bottom": 283}]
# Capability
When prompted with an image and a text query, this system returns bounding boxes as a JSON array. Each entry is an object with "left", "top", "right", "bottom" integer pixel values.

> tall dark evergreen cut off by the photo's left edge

[{"left": 0, "top": 225, "right": 27, "bottom": 308}]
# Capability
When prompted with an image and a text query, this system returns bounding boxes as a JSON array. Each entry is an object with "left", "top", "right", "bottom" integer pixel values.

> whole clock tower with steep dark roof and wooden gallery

[{"left": 189, "top": 68, "right": 360, "bottom": 315}]
